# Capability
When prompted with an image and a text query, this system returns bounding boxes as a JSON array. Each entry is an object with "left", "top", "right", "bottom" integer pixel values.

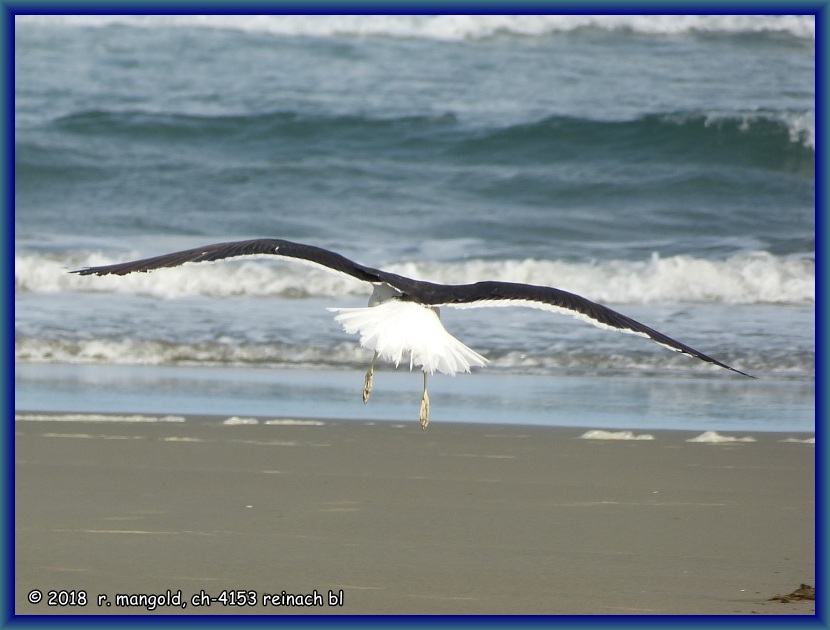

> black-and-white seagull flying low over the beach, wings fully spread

[{"left": 72, "top": 238, "right": 755, "bottom": 430}]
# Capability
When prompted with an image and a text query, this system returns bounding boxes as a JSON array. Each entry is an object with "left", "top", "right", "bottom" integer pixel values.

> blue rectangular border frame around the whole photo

[{"left": 0, "top": 0, "right": 830, "bottom": 627}]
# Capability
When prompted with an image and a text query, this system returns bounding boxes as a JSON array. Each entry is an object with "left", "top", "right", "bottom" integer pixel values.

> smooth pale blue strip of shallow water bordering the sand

[{"left": 15, "top": 365, "right": 815, "bottom": 432}]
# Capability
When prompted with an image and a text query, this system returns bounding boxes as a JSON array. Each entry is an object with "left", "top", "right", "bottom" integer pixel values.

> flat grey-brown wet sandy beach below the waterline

[{"left": 15, "top": 418, "right": 815, "bottom": 615}]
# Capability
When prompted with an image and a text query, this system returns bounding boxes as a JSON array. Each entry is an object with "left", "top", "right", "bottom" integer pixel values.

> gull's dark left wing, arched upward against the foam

[{"left": 73, "top": 238, "right": 381, "bottom": 283}]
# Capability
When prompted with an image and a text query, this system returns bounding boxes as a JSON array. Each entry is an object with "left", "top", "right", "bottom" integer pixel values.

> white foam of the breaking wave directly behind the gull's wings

[{"left": 15, "top": 252, "right": 815, "bottom": 304}]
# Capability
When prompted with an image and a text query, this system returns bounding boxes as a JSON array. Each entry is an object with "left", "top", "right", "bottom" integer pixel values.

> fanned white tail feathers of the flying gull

[{"left": 329, "top": 299, "right": 488, "bottom": 376}]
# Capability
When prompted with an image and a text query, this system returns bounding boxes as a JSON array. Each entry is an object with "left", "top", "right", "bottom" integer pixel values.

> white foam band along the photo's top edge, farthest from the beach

[{"left": 15, "top": 15, "right": 815, "bottom": 41}]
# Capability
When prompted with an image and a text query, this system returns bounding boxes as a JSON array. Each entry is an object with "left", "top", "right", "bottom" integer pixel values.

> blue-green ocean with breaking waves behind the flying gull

[{"left": 14, "top": 15, "right": 815, "bottom": 432}]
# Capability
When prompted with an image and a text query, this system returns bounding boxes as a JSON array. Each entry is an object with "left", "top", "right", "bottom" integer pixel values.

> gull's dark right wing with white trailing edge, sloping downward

[{"left": 412, "top": 282, "right": 755, "bottom": 378}]
